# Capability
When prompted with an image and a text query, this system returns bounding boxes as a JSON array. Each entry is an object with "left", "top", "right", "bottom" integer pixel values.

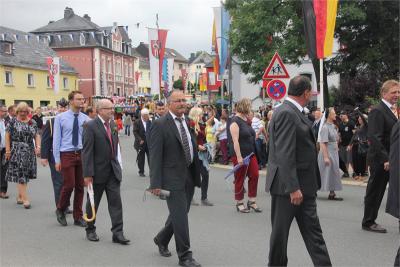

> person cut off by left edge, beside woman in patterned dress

[{"left": 0, "top": 105, "right": 9, "bottom": 199}]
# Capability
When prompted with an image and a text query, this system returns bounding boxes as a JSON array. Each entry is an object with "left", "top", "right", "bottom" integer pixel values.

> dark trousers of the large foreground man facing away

[{"left": 268, "top": 195, "right": 332, "bottom": 266}]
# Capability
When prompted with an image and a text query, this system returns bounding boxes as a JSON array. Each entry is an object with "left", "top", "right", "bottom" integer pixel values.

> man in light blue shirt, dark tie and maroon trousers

[{"left": 53, "top": 91, "right": 89, "bottom": 227}]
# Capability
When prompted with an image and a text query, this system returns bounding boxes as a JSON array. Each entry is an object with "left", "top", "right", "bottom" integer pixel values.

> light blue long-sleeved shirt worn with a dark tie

[{"left": 53, "top": 110, "right": 90, "bottom": 163}]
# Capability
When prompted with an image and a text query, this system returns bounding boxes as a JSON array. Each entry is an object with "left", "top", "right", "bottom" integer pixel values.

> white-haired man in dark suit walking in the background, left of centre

[{"left": 133, "top": 108, "right": 151, "bottom": 177}]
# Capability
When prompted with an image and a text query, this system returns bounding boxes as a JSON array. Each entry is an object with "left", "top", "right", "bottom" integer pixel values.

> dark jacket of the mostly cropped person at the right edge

[{"left": 386, "top": 121, "right": 400, "bottom": 218}]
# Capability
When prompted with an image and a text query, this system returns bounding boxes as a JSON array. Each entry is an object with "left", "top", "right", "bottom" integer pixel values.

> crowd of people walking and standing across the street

[{"left": 0, "top": 76, "right": 400, "bottom": 266}]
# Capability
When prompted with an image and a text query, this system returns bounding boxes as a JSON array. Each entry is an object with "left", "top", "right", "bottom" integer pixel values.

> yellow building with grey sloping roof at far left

[{"left": 0, "top": 26, "right": 79, "bottom": 108}]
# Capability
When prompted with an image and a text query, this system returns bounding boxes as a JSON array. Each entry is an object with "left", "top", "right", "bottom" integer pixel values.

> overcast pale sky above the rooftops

[{"left": 0, "top": 0, "right": 220, "bottom": 57}]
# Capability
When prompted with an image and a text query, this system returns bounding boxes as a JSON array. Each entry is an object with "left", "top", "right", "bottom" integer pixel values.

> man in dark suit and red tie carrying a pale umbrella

[{"left": 82, "top": 99, "right": 130, "bottom": 245}]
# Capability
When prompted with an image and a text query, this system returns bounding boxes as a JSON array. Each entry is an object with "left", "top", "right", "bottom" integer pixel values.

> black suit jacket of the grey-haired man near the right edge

[{"left": 367, "top": 101, "right": 397, "bottom": 164}]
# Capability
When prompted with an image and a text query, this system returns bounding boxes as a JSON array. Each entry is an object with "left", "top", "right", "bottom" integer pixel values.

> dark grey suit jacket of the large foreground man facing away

[{"left": 265, "top": 101, "right": 321, "bottom": 196}]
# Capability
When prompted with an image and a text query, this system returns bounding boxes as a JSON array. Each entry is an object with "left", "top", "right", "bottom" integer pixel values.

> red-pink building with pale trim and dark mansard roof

[{"left": 32, "top": 7, "right": 137, "bottom": 97}]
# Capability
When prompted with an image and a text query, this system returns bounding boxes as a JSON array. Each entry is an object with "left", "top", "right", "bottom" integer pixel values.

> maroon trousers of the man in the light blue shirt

[{"left": 57, "top": 152, "right": 84, "bottom": 220}]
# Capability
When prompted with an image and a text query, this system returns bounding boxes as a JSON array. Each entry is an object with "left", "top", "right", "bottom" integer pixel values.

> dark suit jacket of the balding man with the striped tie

[{"left": 149, "top": 112, "right": 201, "bottom": 191}]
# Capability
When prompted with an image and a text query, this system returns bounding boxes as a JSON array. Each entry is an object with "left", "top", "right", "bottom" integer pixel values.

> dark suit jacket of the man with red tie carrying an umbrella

[{"left": 82, "top": 117, "right": 122, "bottom": 183}]
